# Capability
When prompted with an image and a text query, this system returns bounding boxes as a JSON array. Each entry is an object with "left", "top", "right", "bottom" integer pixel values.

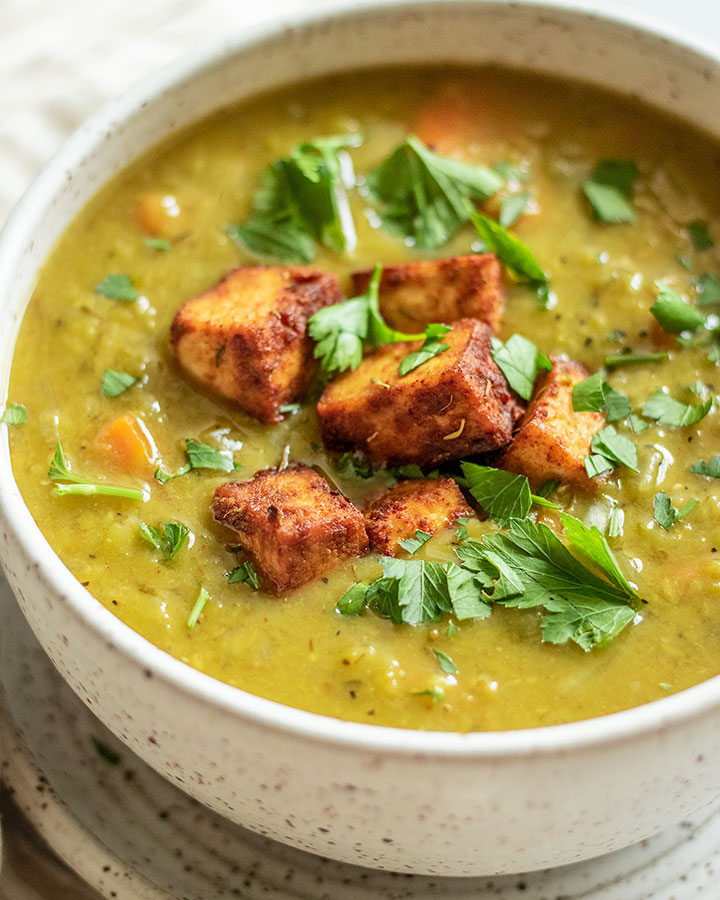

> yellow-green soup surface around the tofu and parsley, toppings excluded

[{"left": 5, "top": 69, "right": 720, "bottom": 731}]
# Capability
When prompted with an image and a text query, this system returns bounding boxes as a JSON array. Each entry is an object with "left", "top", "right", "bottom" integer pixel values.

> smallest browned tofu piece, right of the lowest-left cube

[{"left": 365, "top": 478, "right": 472, "bottom": 556}]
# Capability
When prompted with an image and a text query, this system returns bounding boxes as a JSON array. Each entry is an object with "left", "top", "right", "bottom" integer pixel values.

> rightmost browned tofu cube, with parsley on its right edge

[{"left": 497, "top": 356, "right": 605, "bottom": 488}]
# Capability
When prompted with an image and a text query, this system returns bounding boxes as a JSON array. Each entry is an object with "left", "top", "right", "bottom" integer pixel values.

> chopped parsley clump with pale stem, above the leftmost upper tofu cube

[{"left": 227, "top": 135, "right": 360, "bottom": 263}]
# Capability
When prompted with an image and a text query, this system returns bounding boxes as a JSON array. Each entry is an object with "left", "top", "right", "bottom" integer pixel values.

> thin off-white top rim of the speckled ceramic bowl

[{"left": 0, "top": 0, "right": 720, "bottom": 759}]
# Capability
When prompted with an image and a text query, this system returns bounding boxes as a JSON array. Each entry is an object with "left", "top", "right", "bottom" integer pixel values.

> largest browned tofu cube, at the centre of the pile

[{"left": 318, "top": 319, "right": 522, "bottom": 466}]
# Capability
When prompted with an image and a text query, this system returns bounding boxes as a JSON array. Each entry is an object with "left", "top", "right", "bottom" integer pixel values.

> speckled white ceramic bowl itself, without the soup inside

[{"left": 0, "top": 0, "right": 720, "bottom": 875}]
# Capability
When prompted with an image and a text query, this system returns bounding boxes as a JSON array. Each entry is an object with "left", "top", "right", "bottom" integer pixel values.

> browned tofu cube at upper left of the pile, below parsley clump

[{"left": 171, "top": 266, "right": 341, "bottom": 423}]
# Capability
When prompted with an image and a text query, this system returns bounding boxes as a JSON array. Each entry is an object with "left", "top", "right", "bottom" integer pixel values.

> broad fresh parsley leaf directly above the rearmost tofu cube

[{"left": 367, "top": 137, "right": 503, "bottom": 250}]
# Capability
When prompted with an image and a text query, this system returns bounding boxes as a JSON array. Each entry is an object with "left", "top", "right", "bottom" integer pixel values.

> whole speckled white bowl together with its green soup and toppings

[{"left": 0, "top": 2, "right": 720, "bottom": 875}]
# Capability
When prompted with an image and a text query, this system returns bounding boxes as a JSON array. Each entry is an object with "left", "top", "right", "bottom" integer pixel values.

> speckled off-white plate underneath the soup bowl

[{"left": 0, "top": 576, "right": 720, "bottom": 900}]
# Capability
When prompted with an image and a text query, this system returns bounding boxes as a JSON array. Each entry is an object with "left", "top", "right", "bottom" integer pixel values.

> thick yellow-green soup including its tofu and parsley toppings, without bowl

[{"left": 4, "top": 69, "right": 720, "bottom": 731}]
